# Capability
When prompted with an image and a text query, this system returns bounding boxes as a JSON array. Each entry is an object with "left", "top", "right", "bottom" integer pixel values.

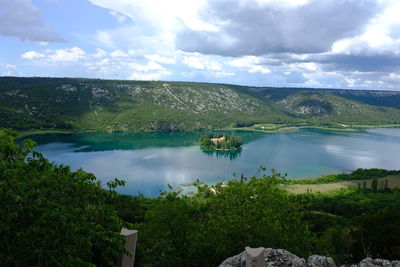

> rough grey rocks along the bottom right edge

[{"left": 220, "top": 248, "right": 400, "bottom": 267}]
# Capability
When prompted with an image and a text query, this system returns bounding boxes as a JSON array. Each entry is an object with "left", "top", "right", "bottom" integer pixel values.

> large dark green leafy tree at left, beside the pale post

[{"left": 0, "top": 129, "right": 128, "bottom": 266}]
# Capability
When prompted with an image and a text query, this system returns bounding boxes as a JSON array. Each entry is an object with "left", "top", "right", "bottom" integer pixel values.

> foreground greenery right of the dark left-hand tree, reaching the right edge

[{"left": 114, "top": 172, "right": 400, "bottom": 266}]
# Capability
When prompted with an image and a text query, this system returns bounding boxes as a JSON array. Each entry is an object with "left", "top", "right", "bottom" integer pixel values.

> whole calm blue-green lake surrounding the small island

[{"left": 22, "top": 128, "right": 400, "bottom": 197}]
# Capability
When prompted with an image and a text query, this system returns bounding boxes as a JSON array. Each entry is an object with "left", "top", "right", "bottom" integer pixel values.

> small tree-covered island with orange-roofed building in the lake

[{"left": 200, "top": 133, "right": 243, "bottom": 150}]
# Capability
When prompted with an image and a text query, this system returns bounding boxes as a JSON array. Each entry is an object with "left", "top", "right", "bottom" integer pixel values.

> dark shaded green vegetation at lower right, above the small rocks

[{"left": 294, "top": 189, "right": 400, "bottom": 262}]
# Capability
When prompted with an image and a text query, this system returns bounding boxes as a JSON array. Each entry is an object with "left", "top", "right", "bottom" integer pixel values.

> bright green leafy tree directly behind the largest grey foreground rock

[{"left": 200, "top": 172, "right": 322, "bottom": 263}]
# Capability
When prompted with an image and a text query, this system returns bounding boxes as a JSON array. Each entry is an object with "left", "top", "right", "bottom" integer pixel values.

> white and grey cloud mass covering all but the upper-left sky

[{"left": 10, "top": 0, "right": 400, "bottom": 89}]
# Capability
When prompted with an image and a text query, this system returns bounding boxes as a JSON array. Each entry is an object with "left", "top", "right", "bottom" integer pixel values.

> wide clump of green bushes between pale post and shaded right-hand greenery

[{"left": 131, "top": 170, "right": 326, "bottom": 266}]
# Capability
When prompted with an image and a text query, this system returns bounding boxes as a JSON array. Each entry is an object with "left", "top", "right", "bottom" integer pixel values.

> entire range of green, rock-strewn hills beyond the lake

[{"left": 0, "top": 77, "right": 400, "bottom": 131}]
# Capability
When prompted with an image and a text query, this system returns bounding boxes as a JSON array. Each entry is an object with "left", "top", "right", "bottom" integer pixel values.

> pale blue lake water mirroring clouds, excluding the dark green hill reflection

[{"left": 32, "top": 129, "right": 400, "bottom": 196}]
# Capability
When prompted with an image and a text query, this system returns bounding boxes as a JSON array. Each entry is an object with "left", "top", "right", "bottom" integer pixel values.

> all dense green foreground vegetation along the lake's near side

[{"left": 0, "top": 130, "right": 400, "bottom": 266}]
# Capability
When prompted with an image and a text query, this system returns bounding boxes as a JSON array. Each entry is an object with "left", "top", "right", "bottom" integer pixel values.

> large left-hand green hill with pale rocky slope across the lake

[{"left": 0, "top": 77, "right": 284, "bottom": 132}]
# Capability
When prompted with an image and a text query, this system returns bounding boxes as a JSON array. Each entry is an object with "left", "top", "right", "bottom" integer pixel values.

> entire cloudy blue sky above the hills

[{"left": 0, "top": 0, "right": 400, "bottom": 90}]
